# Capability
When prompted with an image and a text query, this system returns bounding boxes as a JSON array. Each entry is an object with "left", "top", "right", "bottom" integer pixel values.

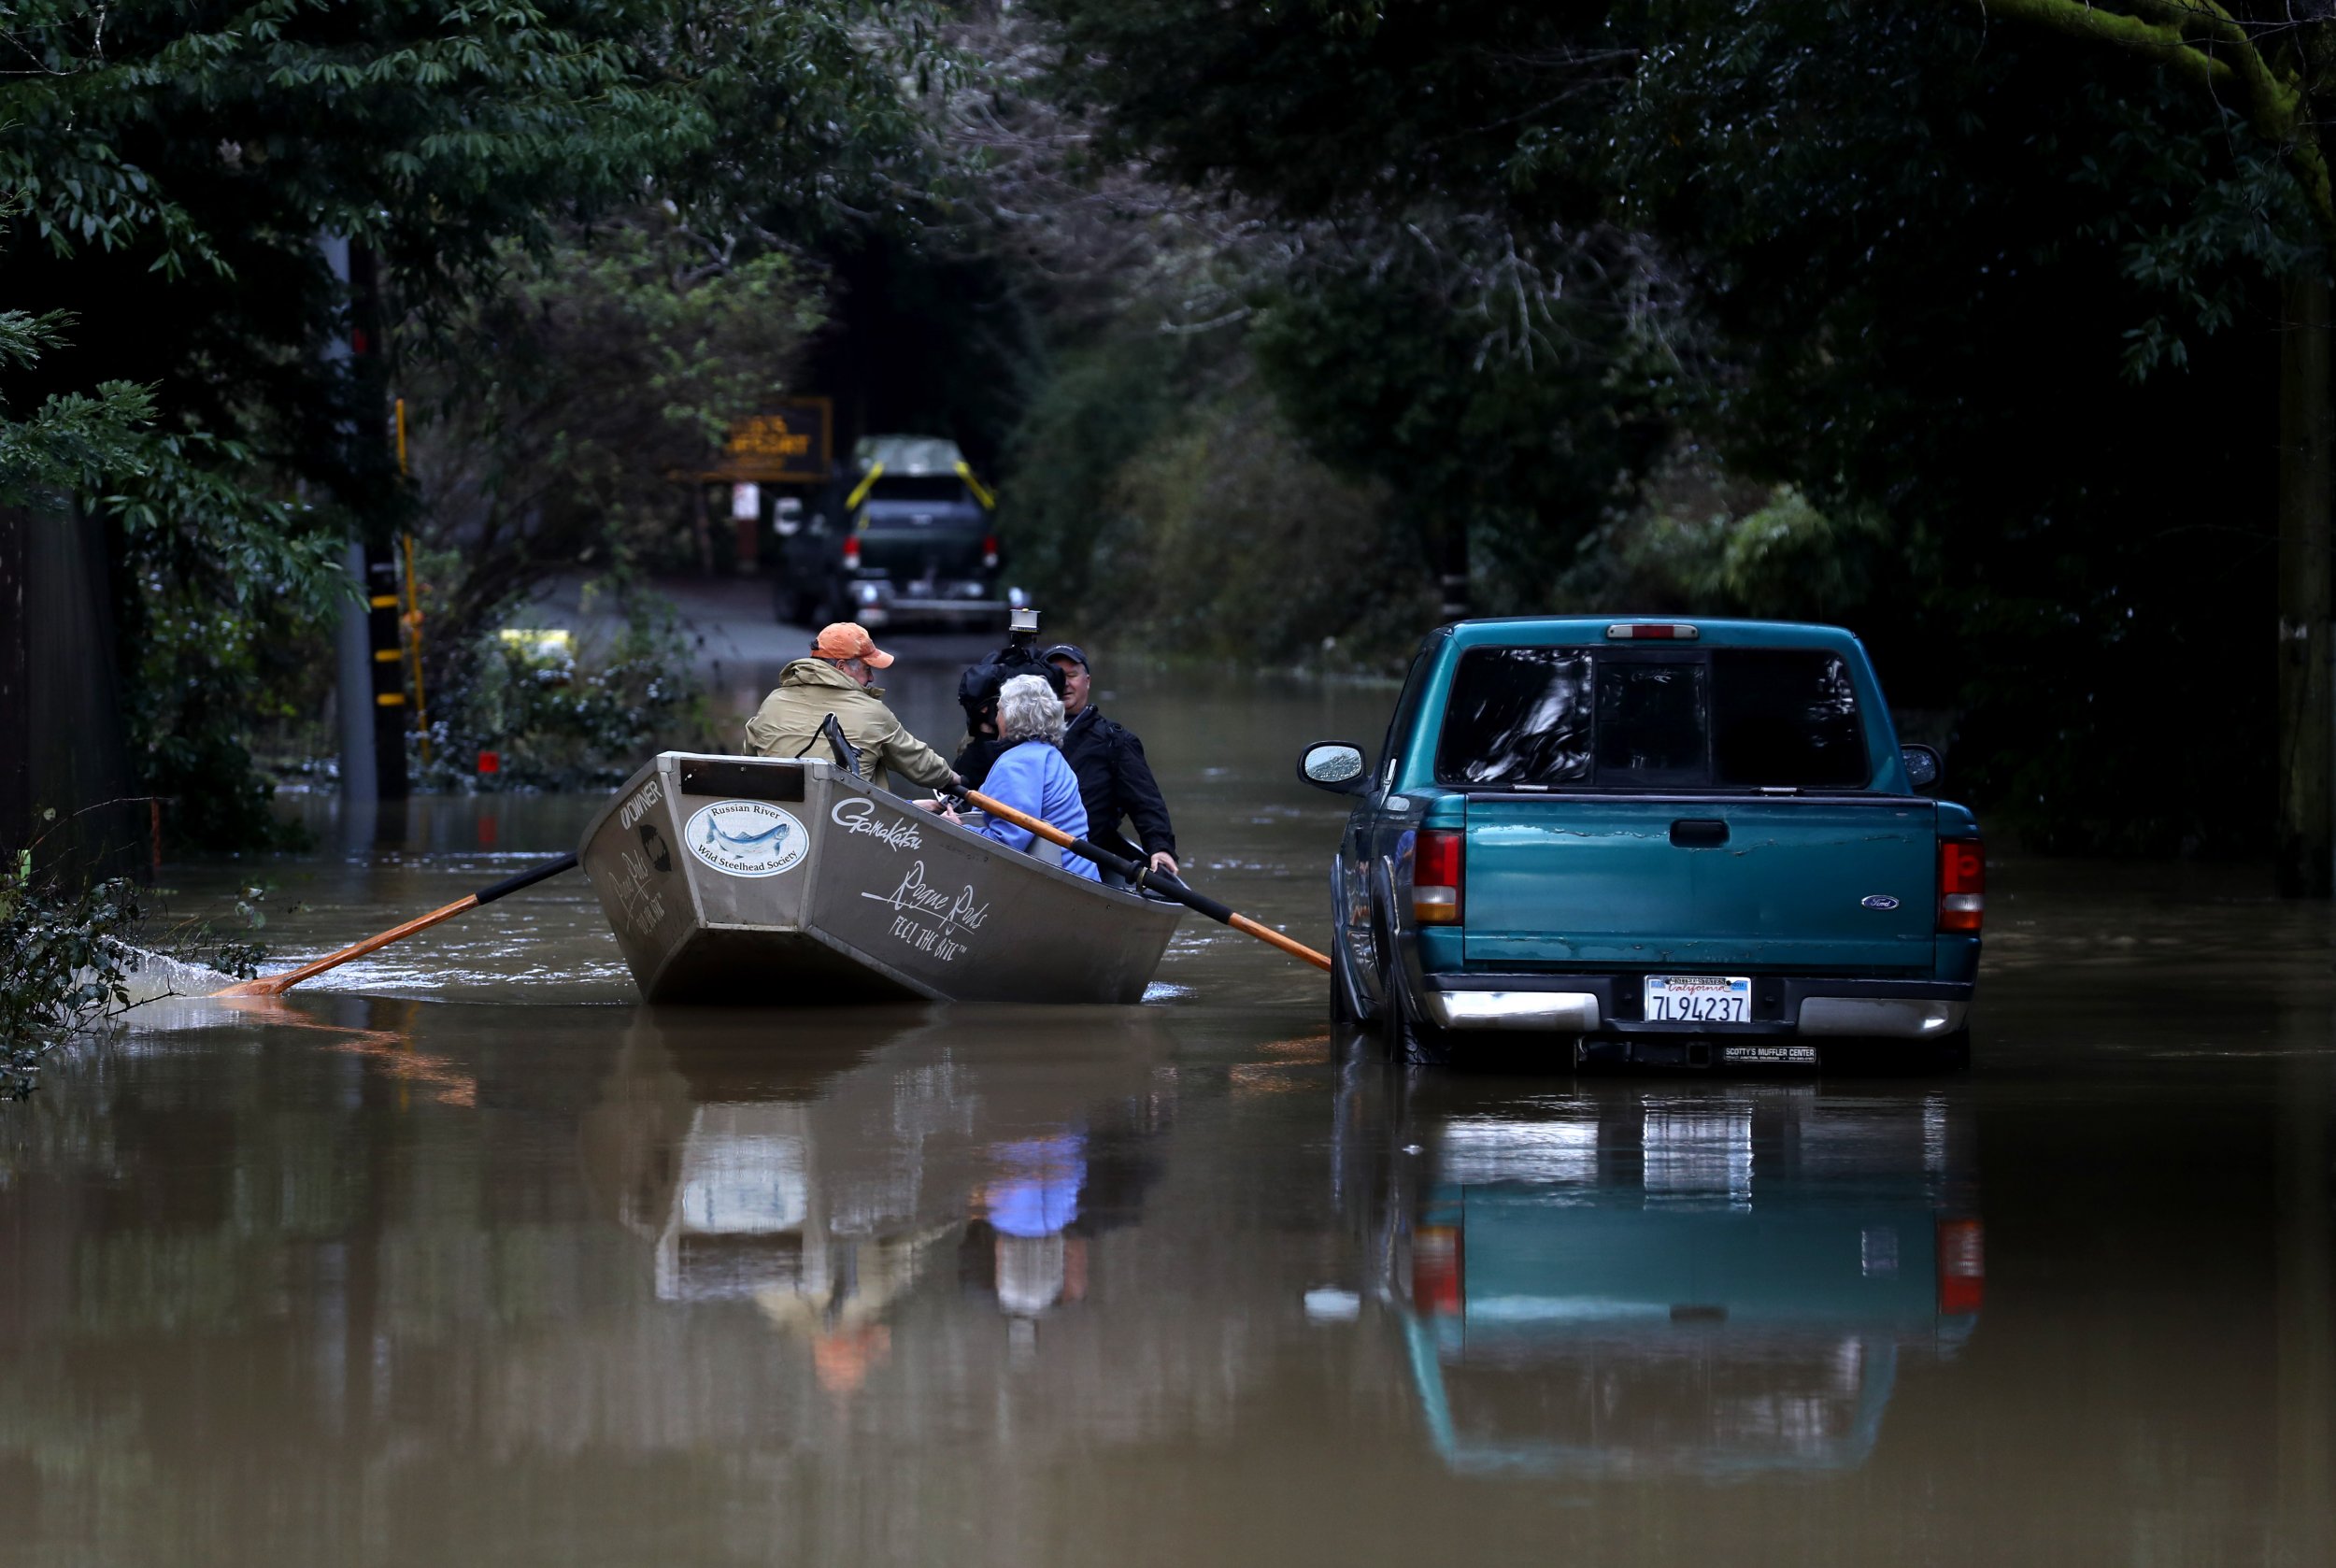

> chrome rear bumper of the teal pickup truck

[{"left": 1420, "top": 975, "right": 1972, "bottom": 1040}]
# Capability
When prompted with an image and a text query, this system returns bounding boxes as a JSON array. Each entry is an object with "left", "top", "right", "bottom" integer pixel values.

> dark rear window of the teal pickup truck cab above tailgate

[{"left": 1437, "top": 648, "right": 1872, "bottom": 790}]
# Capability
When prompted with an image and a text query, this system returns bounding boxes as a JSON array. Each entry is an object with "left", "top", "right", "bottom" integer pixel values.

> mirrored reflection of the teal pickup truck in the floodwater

[{"left": 1374, "top": 1079, "right": 1984, "bottom": 1476}]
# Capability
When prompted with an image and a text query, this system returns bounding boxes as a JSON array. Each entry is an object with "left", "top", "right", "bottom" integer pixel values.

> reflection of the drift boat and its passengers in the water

[{"left": 584, "top": 1009, "right": 1173, "bottom": 1392}]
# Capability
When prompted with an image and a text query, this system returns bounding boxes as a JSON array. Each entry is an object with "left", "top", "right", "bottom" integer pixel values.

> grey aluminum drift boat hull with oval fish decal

[{"left": 577, "top": 752, "right": 1182, "bottom": 1005}]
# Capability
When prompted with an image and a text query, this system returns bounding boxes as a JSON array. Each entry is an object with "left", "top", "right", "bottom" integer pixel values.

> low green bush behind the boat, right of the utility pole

[{"left": 430, "top": 593, "right": 710, "bottom": 790}]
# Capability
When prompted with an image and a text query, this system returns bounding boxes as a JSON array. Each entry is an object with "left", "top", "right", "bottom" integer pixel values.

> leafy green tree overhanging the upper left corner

[{"left": 0, "top": 0, "right": 948, "bottom": 839}]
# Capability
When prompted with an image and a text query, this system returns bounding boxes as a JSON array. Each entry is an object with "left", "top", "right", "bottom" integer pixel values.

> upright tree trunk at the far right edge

[{"left": 2278, "top": 271, "right": 2336, "bottom": 897}]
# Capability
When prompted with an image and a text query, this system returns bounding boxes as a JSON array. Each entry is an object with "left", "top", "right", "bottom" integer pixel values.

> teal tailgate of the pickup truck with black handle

[{"left": 1462, "top": 797, "right": 1937, "bottom": 972}]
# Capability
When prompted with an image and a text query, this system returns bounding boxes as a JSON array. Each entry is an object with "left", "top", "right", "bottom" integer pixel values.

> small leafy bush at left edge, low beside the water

[{"left": 0, "top": 850, "right": 138, "bottom": 1098}]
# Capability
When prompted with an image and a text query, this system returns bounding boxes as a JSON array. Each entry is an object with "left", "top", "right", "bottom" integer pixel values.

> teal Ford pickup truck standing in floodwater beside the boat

[{"left": 1299, "top": 617, "right": 1986, "bottom": 1068}]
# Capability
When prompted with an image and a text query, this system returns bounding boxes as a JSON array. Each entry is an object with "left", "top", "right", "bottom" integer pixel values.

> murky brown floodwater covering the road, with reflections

[{"left": 0, "top": 645, "right": 2336, "bottom": 1568}]
